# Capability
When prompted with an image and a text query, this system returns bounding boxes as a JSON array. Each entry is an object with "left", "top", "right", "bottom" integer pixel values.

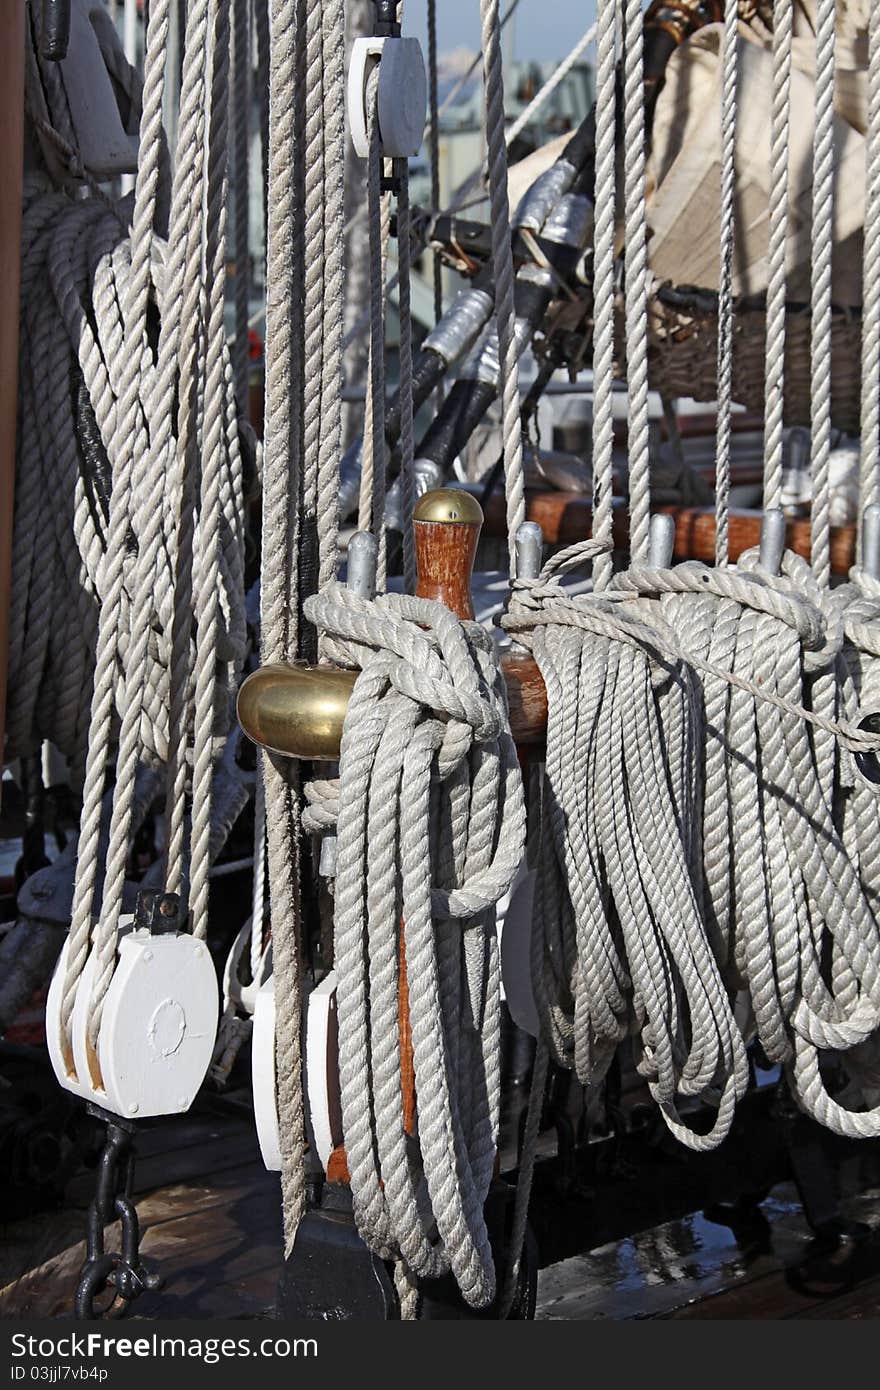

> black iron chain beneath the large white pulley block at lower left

[{"left": 74, "top": 1104, "right": 163, "bottom": 1321}]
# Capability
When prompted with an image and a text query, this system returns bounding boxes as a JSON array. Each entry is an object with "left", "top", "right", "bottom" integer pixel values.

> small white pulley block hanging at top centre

[{"left": 348, "top": 38, "right": 428, "bottom": 160}]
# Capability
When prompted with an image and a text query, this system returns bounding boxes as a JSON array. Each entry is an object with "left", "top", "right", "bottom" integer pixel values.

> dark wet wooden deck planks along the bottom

[{"left": 0, "top": 1101, "right": 880, "bottom": 1321}]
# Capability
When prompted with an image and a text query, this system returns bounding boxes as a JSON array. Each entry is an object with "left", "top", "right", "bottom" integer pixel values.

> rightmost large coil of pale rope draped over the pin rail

[{"left": 603, "top": 552, "right": 880, "bottom": 1136}]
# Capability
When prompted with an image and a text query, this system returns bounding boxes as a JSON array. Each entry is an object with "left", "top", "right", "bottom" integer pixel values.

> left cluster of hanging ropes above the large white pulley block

[{"left": 13, "top": 0, "right": 246, "bottom": 1047}]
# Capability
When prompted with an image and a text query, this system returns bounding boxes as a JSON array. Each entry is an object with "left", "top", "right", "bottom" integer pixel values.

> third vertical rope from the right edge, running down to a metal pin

[{"left": 763, "top": 0, "right": 792, "bottom": 509}]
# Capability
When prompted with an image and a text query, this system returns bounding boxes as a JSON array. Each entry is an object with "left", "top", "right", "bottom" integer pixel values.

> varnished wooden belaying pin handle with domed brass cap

[{"left": 413, "top": 488, "right": 482, "bottom": 619}]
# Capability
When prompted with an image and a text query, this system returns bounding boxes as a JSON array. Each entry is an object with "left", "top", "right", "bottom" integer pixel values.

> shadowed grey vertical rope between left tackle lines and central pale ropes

[{"left": 232, "top": 0, "right": 250, "bottom": 420}]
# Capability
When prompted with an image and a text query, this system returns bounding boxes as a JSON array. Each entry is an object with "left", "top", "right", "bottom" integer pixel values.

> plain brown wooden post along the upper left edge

[{"left": 0, "top": 0, "right": 25, "bottom": 760}]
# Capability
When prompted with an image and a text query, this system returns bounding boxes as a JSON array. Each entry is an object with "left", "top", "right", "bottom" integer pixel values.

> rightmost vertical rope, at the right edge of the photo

[{"left": 856, "top": 4, "right": 880, "bottom": 557}]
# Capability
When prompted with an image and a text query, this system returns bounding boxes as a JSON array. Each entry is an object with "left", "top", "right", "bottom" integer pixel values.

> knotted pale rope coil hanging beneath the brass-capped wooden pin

[{"left": 304, "top": 584, "right": 525, "bottom": 1307}]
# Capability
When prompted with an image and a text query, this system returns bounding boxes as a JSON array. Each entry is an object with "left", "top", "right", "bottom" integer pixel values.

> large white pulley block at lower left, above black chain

[{"left": 46, "top": 930, "right": 218, "bottom": 1119}]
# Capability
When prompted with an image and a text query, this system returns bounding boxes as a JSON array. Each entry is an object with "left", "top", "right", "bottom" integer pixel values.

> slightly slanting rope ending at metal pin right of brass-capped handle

[{"left": 480, "top": 0, "right": 525, "bottom": 575}]
